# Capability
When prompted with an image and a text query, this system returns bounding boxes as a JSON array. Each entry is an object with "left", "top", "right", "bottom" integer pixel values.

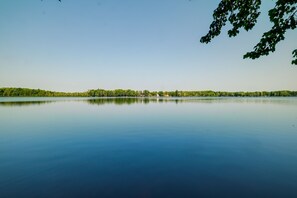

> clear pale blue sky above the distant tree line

[{"left": 0, "top": 0, "right": 297, "bottom": 91}]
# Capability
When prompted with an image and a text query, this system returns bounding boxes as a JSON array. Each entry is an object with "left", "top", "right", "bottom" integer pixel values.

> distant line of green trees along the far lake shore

[{"left": 0, "top": 88, "right": 297, "bottom": 97}]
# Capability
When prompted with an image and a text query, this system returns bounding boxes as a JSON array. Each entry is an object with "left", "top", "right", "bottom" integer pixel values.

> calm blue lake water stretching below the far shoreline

[{"left": 0, "top": 98, "right": 297, "bottom": 198}]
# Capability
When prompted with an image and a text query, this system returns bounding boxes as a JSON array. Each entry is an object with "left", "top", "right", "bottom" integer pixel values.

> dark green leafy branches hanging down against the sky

[{"left": 200, "top": 0, "right": 297, "bottom": 65}]
